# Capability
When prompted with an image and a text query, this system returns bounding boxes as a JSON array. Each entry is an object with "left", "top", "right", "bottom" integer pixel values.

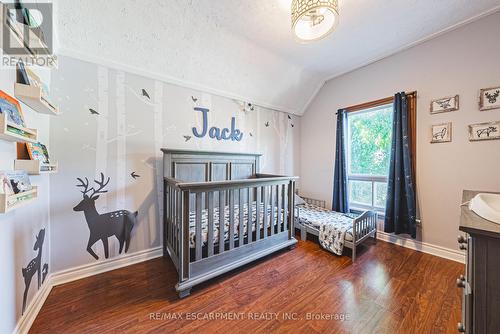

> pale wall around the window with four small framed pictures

[{"left": 301, "top": 9, "right": 500, "bottom": 249}]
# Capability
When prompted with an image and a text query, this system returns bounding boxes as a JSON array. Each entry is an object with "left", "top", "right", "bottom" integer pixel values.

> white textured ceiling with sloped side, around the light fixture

[{"left": 52, "top": 0, "right": 500, "bottom": 115}]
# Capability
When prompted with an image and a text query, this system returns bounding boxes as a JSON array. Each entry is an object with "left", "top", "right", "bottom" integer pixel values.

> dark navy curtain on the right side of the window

[{"left": 384, "top": 93, "right": 417, "bottom": 238}]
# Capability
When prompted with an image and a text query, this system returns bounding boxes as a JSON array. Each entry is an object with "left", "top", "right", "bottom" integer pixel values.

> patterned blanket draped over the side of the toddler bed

[{"left": 297, "top": 204, "right": 355, "bottom": 255}]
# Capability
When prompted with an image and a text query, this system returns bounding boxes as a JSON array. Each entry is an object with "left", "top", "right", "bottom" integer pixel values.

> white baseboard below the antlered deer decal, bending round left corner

[{"left": 14, "top": 247, "right": 163, "bottom": 334}]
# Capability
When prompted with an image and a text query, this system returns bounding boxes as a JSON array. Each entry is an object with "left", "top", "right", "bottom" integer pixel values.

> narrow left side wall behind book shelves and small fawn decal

[{"left": 0, "top": 67, "right": 51, "bottom": 333}]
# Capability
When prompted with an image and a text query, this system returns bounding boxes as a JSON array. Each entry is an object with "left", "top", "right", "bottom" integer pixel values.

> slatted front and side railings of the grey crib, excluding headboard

[{"left": 164, "top": 174, "right": 296, "bottom": 297}]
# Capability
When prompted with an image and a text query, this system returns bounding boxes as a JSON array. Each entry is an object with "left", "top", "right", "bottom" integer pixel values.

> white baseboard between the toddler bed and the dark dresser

[{"left": 377, "top": 231, "right": 465, "bottom": 263}]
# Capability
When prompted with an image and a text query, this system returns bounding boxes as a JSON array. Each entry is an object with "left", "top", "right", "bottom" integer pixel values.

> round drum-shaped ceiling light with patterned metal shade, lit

[{"left": 292, "top": 0, "right": 339, "bottom": 42}]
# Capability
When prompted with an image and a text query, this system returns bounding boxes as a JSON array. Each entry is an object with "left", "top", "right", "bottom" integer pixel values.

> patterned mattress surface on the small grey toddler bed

[{"left": 297, "top": 204, "right": 354, "bottom": 241}]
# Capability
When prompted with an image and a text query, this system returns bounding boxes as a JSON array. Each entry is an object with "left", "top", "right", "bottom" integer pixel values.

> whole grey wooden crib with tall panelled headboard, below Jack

[{"left": 162, "top": 149, "right": 298, "bottom": 298}]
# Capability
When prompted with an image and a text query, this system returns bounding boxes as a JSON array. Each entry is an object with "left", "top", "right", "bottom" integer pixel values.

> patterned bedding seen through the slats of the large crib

[{"left": 189, "top": 201, "right": 284, "bottom": 248}]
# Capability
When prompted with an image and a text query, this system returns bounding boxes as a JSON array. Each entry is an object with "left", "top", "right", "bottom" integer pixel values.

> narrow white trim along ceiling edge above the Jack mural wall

[{"left": 56, "top": 47, "right": 302, "bottom": 116}]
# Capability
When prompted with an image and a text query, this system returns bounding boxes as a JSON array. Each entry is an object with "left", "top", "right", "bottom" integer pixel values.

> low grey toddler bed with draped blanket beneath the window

[{"left": 295, "top": 197, "right": 377, "bottom": 262}]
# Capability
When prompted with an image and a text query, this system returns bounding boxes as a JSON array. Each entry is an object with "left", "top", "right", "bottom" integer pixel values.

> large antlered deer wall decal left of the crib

[{"left": 73, "top": 173, "right": 138, "bottom": 260}]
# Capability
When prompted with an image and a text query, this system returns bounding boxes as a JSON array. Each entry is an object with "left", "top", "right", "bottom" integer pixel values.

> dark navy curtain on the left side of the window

[{"left": 332, "top": 109, "right": 349, "bottom": 213}]
